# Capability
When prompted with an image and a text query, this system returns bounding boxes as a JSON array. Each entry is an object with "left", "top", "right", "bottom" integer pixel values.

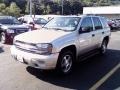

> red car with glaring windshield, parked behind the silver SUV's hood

[{"left": 18, "top": 15, "right": 48, "bottom": 30}]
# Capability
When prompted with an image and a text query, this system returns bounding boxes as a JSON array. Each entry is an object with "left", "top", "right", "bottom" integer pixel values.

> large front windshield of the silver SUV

[{"left": 43, "top": 17, "right": 80, "bottom": 31}]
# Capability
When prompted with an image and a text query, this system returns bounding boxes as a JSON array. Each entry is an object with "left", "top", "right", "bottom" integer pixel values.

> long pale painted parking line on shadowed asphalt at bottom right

[{"left": 89, "top": 63, "right": 120, "bottom": 90}]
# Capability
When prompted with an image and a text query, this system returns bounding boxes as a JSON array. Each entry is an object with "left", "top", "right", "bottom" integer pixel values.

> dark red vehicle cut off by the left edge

[{"left": 0, "top": 16, "right": 30, "bottom": 44}]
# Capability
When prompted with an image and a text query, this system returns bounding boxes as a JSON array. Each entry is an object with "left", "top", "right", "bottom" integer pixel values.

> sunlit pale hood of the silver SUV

[{"left": 15, "top": 29, "right": 71, "bottom": 43}]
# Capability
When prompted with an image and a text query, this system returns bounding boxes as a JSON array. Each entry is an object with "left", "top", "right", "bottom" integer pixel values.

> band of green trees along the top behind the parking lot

[{"left": 0, "top": 0, "right": 119, "bottom": 16}]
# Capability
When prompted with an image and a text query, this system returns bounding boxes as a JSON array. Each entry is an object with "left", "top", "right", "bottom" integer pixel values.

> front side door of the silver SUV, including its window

[{"left": 79, "top": 17, "right": 93, "bottom": 54}]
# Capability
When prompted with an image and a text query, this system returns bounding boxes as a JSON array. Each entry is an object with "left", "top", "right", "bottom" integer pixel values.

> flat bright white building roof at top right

[{"left": 83, "top": 6, "right": 120, "bottom": 14}]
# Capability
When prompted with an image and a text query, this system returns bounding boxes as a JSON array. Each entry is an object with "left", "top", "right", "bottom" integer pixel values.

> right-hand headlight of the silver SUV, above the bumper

[{"left": 36, "top": 43, "right": 53, "bottom": 54}]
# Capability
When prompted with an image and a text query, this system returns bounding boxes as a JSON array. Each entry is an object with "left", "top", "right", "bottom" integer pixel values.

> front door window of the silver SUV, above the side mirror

[{"left": 80, "top": 17, "right": 93, "bottom": 31}]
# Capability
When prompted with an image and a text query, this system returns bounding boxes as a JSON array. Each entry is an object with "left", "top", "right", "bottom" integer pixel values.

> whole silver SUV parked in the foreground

[{"left": 11, "top": 15, "right": 111, "bottom": 74}]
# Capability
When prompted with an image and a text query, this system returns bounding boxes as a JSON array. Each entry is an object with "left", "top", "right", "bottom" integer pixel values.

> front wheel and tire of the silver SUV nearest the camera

[{"left": 57, "top": 50, "right": 74, "bottom": 75}]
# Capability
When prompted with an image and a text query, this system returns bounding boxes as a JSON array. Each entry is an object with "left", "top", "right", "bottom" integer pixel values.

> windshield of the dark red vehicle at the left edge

[{"left": 0, "top": 17, "right": 22, "bottom": 25}]
